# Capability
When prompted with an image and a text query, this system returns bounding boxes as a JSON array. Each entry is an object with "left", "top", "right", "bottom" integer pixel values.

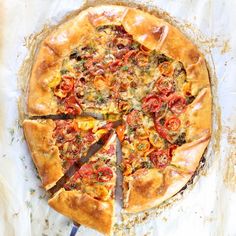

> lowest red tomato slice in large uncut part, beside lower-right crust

[{"left": 149, "top": 149, "right": 171, "bottom": 169}]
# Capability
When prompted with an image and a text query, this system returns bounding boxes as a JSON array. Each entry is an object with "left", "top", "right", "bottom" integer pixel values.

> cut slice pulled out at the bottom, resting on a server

[{"left": 48, "top": 134, "right": 116, "bottom": 234}]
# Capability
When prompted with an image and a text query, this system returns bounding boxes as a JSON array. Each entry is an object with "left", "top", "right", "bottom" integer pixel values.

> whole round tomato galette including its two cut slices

[{"left": 23, "top": 5, "right": 211, "bottom": 234}]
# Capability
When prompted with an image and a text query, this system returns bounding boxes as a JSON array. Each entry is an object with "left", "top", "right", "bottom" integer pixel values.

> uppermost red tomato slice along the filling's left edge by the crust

[{"left": 54, "top": 76, "right": 74, "bottom": 98}]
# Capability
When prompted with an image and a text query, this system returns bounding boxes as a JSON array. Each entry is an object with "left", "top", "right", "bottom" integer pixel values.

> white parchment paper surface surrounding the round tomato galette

[{"left": 0, "top": 0, "right": 236, "bottom": 236}]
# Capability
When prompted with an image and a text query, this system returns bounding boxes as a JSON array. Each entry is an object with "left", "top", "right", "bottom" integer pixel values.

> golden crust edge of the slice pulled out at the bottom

[{"left": 48, "top": 189, "right": 114, "bottom": 235}]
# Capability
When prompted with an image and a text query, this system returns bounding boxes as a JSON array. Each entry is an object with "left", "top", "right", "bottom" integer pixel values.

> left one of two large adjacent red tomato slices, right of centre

[{"left": 142, "top": 94, "right": 162, "bottom": 112}]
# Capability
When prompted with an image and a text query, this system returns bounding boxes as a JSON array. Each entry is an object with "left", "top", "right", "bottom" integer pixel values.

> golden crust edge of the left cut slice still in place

[{"left": 23, "top": 120, "right": 63, "bottom": 190}]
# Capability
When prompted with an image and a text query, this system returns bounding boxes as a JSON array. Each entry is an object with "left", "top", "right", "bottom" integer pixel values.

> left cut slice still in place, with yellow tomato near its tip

[{"left": 23, "top": 117, "right": 111, "bottom": 190}]
